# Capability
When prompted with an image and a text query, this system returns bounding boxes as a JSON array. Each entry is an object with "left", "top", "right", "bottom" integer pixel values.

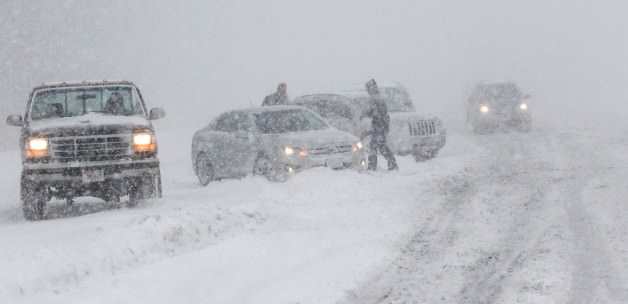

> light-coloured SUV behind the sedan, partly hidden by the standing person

[{"left": 293, "top": 84, "right": 447, "bottom": 161}]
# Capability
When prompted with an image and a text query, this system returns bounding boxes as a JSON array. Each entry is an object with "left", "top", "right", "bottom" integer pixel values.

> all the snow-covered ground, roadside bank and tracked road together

[{"left": 0, "top": 127, "right": 628, "bottom": 303}]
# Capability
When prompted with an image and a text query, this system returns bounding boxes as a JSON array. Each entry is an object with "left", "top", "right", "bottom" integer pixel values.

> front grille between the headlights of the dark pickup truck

[{"left": 50, "top": 134, "right": 132, "bottom": 162}]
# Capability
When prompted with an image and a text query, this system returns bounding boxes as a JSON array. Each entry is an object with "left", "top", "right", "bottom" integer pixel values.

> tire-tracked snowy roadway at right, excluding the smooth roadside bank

[{"left": 343, "top": 130, "right": 628, "bottom": 303}]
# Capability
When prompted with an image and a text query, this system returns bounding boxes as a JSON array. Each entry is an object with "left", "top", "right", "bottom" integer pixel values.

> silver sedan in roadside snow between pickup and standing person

[{"left": 192, "top": 106, "right": 366, "bottom": 185}]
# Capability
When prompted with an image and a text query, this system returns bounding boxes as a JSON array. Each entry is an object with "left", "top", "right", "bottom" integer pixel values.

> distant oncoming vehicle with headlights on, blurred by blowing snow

[{"left": 467, "top": 82, "right": 532, "bottom": 133}]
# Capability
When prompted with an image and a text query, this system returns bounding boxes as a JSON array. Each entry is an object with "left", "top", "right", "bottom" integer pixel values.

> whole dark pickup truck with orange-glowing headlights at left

[{"left": 7, "top": 81, "right": 165, "bottom": 220}]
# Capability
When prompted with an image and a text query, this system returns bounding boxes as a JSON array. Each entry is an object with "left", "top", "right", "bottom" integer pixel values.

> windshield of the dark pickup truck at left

[{"left": 30, "top": 86, "right": 144, "bottom": 120}]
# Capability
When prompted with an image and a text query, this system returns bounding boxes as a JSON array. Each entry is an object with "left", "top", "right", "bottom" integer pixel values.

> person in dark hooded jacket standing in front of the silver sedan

[{"left": 363, "top": 79, "right": 399, "bottom": 170}]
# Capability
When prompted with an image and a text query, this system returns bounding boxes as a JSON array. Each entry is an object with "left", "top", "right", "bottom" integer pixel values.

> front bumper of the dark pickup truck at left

[{"left": 23, "top": 158, "right": 160, "bottom": 184}]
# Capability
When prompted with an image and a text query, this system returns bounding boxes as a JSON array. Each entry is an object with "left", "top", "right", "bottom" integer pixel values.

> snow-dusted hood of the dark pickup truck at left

[{"left": 29, "top": 113, "right": 150, "bottom": 132}]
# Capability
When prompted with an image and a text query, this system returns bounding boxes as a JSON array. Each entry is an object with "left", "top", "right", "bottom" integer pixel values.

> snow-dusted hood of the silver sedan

[{"left": 269, "top": 128, "right": 358, "bottom": 147}]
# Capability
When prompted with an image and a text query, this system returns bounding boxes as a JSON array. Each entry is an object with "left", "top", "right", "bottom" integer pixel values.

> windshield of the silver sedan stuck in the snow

[{"left": 255, "top": 110, "right": 328, "bottom": 134}]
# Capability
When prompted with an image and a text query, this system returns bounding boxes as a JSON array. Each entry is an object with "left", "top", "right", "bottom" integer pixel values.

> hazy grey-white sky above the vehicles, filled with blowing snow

[{"left": 0, "top": 0, "right": 628, "bottom": 130}]
